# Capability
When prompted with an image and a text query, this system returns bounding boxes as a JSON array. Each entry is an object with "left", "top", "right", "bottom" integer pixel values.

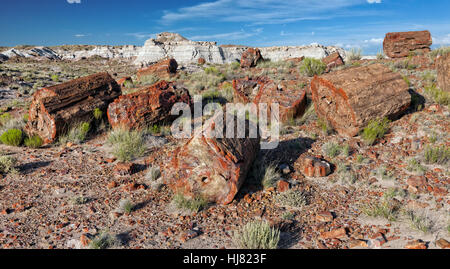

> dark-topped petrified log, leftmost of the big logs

[{"left": 26, "top": 73, "right": 121, "bottom": 143}]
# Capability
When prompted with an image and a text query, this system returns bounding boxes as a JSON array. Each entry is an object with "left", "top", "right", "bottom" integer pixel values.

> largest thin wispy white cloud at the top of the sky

[{"left": 161, "top": 0, "right": 367, "bottom": 25}]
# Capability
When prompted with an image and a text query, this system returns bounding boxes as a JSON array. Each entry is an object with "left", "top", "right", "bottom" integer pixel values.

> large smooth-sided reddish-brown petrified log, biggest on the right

[{"left": 311, "top": 64, "right": 411, "bottom": 137}]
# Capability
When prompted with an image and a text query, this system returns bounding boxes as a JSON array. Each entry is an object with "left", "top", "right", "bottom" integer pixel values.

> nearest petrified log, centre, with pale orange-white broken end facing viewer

[{"left": 163, "top": 111, "right": 260, "bottom": 204}]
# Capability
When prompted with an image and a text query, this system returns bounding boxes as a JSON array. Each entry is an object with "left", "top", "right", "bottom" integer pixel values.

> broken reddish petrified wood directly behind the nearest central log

[{"left": 233, "top": 77, "right": 307, "bottom": 122}]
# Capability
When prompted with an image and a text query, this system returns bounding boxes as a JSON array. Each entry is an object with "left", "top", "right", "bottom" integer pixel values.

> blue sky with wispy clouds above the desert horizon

[{"left": 0, "top": 0, "right": 450, "bottom": 54}]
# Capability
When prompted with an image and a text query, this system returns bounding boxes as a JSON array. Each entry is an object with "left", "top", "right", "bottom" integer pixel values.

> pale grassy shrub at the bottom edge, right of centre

[{"left": 233, "top": 221, "right": 280, "bottom": 249}]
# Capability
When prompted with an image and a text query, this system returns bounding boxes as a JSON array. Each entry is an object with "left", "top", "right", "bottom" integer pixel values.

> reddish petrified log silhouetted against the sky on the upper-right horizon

[{"left": 383, "top": 31, "right": 433, "bottom": 58}]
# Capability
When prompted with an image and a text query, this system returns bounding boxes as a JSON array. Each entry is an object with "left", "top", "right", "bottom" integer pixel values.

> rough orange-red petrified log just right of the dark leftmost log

[{"left": 108, "top": 81, "right": 191, "bottom": 129}]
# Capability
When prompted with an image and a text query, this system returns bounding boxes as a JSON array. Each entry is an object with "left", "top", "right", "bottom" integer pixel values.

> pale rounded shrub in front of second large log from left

[{"left": 107, "top": 128, "right": 145, "bottom": 162}]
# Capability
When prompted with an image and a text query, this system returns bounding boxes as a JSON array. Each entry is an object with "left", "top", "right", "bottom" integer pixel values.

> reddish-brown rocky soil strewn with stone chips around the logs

[{"left": 0, "top": 46, "right": 450, "bottom": 249}]
